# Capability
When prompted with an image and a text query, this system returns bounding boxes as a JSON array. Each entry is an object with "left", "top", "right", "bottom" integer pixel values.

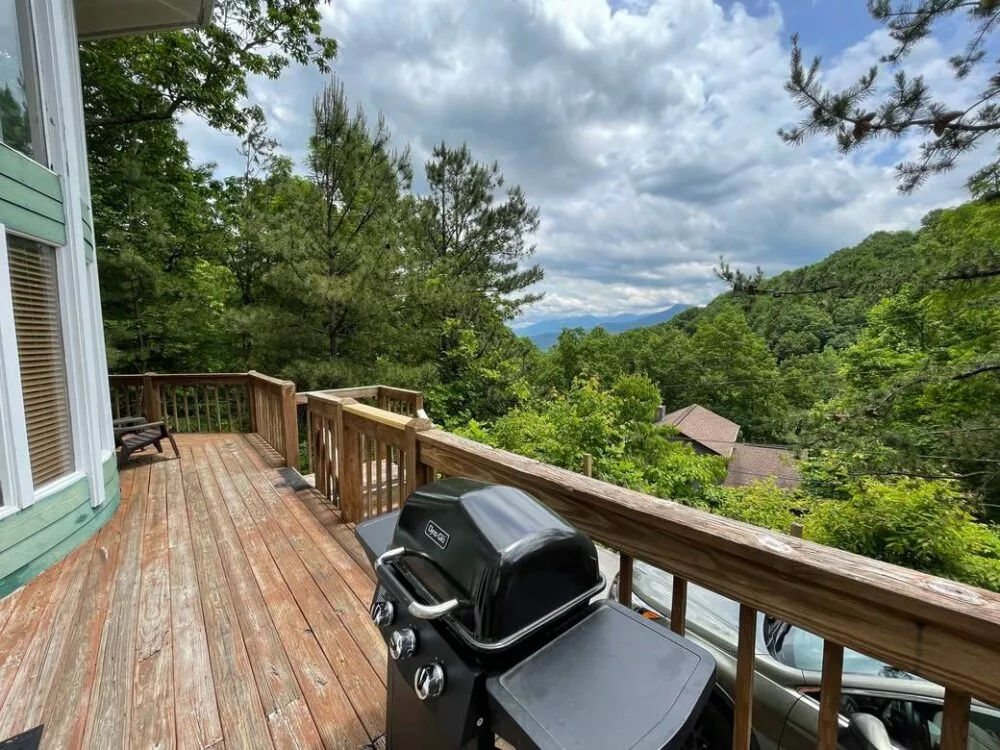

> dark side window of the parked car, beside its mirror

[{"left": 840, "top": 691, "right": 1000, "bottom": 750}]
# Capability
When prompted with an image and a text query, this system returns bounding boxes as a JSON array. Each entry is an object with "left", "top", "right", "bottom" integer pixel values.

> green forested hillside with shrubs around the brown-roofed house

[{"left": 486, "top": 200, "right": 1000, "bottom": 588}]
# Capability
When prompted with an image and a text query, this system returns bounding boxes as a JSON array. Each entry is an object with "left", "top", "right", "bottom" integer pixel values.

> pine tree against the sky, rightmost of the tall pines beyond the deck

[{"left": 401, "top": 144, "right": 543, "bottom": 420}]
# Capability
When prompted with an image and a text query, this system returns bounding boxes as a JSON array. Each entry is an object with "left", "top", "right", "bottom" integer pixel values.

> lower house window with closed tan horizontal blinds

[{"left": 7, "top": 235, "right": 73, "bottom": 487}]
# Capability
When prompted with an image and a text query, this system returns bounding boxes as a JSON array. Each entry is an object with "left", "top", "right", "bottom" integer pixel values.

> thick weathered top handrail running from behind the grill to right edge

[{"left": 417, "top": 430, "right": 1000, "bottom": 703}]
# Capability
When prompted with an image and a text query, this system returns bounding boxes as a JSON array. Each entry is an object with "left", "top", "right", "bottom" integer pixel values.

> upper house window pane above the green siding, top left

[{"left": 0, "top": 0, "right": 45, "bottom": 162}]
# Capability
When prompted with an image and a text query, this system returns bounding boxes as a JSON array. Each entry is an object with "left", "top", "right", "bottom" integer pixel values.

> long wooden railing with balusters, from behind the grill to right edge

[{"left": 307, "top": 402, "right": 1000, "bottom": 750}]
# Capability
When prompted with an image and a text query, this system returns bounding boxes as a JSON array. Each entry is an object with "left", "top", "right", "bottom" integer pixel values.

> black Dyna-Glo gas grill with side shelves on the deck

[{"left": 358, "top": 479, "right": 715, "bottom": 750}]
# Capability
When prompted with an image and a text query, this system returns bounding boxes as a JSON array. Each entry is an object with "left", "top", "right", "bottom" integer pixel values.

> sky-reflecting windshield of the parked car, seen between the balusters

[{"left": 633, "top": 562, "right": 920, "bottom": 679}]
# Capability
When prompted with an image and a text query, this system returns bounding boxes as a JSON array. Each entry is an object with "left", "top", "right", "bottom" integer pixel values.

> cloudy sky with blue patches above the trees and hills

[{"left": 182, "top": 0, "right": 977, "bottom": 322}]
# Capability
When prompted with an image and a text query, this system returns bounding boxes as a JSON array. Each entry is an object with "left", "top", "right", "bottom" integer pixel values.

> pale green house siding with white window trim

[{"left": 0, "top": 0, "right": 121, "bottom": 597}]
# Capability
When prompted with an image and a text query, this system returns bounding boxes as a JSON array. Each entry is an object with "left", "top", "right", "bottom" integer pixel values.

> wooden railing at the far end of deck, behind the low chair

[{"left": 108, "top": 372, "right": 299, "bottom": 468}]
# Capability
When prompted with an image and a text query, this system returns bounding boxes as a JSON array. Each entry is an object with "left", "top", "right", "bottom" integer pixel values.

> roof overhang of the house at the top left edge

[{"left": 73, "top": 0, "right": 214, "bottom": 41}]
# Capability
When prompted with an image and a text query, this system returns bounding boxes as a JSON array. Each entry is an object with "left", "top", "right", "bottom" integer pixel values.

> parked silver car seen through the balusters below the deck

[{"left": 609, "top": 562, "right": 1000, "bottom": 750}]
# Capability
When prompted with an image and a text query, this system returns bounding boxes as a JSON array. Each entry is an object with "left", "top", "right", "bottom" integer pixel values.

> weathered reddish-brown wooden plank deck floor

[{"left": 0, "top": 434, "right": 386, "bottom": 749}]
